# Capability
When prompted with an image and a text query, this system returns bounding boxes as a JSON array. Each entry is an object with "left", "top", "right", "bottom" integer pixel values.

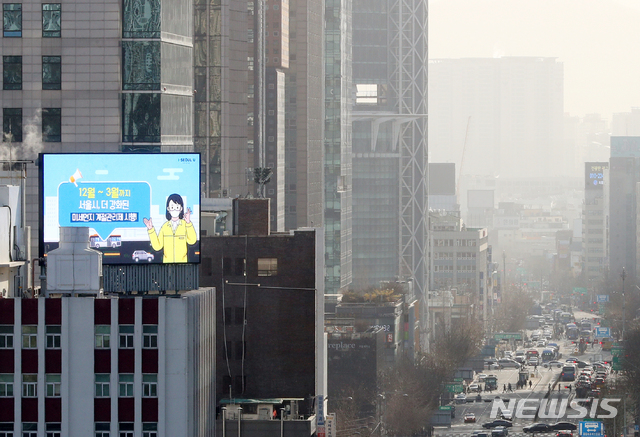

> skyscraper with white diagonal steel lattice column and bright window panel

[{"left": 352, "top": 0, "right": 428, "bottom": 314}]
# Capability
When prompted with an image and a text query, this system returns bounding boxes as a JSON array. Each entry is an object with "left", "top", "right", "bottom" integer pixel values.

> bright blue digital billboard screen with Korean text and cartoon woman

[{"left": 40, "top": 153, "right": 200, "bottom": 264}]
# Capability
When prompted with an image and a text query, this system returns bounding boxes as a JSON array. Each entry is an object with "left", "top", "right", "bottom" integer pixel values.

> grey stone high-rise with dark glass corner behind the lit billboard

[{"left": 0, "top": 0, "right": 193, "bottom": 278}]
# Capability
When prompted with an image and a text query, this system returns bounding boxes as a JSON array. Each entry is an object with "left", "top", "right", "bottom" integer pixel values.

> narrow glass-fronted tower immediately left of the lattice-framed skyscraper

[{"left": 324, "top": 0, "right": 353, "bottom": 293}]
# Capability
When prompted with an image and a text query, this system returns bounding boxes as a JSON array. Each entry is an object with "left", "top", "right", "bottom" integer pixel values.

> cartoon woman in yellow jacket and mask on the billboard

[{"left": 142, "top": 194, "right": 197, "bottom": 263}]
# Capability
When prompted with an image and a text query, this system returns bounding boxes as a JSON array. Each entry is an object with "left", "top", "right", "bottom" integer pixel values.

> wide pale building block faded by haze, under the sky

[{"left": 429, "top": 57, "right": 560, "bottom": 179}]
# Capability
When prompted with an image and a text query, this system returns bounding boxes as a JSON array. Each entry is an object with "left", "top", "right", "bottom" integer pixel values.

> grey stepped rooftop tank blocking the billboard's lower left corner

[{"left": 47, "top": 227, "right": 102, "bottom": 294}]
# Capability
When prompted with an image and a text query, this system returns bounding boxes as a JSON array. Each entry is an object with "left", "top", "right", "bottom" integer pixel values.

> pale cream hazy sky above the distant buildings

[{"left": 429, "top": 0, "right": 640, "bottom": 118}]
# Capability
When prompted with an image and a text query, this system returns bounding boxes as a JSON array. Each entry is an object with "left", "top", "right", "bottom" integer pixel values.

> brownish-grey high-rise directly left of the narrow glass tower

[{"left": 285, "top": 0, "right": 325, "bottom": 229}]
